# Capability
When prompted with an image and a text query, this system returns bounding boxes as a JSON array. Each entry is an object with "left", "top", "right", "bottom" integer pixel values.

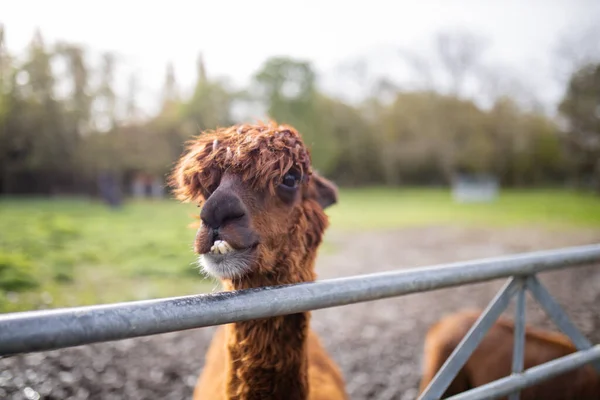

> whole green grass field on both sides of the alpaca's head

[{"left": 0, "top": 189, "right": 600, "bottom": 312}]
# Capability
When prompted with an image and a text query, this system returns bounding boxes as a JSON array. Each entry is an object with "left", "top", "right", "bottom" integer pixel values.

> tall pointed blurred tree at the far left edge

[{"left": 3, "top": 31, "right": 77, "bottom": 192}]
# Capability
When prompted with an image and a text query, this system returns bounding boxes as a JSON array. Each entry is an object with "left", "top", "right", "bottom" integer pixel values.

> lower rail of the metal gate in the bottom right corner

[{"left": 447, "top": 345, "right": 600, "bottom": 400}]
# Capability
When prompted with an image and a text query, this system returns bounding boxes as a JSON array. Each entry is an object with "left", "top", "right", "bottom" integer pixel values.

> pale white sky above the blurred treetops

[{"left": 0, "top": 0, "right": 600, "bottom": 115}]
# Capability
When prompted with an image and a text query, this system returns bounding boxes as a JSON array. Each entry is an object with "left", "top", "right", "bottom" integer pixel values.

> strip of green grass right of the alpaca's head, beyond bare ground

[{"left": 328, "top": 188, "right": 600, "bottom": 230}]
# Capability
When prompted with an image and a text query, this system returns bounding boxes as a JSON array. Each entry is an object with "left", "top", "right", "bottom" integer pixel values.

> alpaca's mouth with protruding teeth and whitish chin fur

[{"left": 199, "top": 240, "right": 257, "bottom": 279}]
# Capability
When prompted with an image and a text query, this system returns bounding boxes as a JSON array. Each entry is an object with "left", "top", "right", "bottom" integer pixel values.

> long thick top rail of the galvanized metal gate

[{"left": 0, "top": 245, "right": 600, "bottom": 356}]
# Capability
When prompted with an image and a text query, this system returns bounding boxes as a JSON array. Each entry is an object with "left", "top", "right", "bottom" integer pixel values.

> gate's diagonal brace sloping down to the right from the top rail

[{"left": 527, "top": 276, "right": 600, "bottom": 372}]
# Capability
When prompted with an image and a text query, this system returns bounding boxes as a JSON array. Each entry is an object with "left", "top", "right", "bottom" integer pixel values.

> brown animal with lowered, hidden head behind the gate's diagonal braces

[{"left": 419, "top": 311, "right": 600, "bottom": 400}]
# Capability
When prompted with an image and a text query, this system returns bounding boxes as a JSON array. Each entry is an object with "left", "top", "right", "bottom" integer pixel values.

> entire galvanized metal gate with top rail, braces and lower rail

[{"left": 0, "top": 245, "right": 600, "bottom": 400}]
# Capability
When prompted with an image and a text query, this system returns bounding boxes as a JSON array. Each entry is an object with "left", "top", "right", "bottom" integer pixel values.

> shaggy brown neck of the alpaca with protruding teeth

[{"left": 225, "top": 252, "right": 315, "bottom": 400}]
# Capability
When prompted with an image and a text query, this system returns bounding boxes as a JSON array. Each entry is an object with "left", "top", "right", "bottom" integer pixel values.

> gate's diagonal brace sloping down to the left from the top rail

[{"left": 418, "top": 278, "right": 523, "bottom": 400}]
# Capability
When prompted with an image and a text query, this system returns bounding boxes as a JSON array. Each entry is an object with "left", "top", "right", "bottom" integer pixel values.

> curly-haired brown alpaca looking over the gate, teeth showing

[{"left": 171, "top": 122, "right": 347, "bottom": 400}]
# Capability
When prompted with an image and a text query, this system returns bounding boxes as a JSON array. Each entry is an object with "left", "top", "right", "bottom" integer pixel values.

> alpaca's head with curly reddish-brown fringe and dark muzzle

[{"left": 171, "top": 122, "right": 337, "bottom": 280}]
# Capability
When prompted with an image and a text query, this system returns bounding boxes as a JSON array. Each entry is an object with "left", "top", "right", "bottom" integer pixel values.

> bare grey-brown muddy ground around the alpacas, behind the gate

[{"left": 0, "top": 227, "right": 600, "bottom": 400}]
